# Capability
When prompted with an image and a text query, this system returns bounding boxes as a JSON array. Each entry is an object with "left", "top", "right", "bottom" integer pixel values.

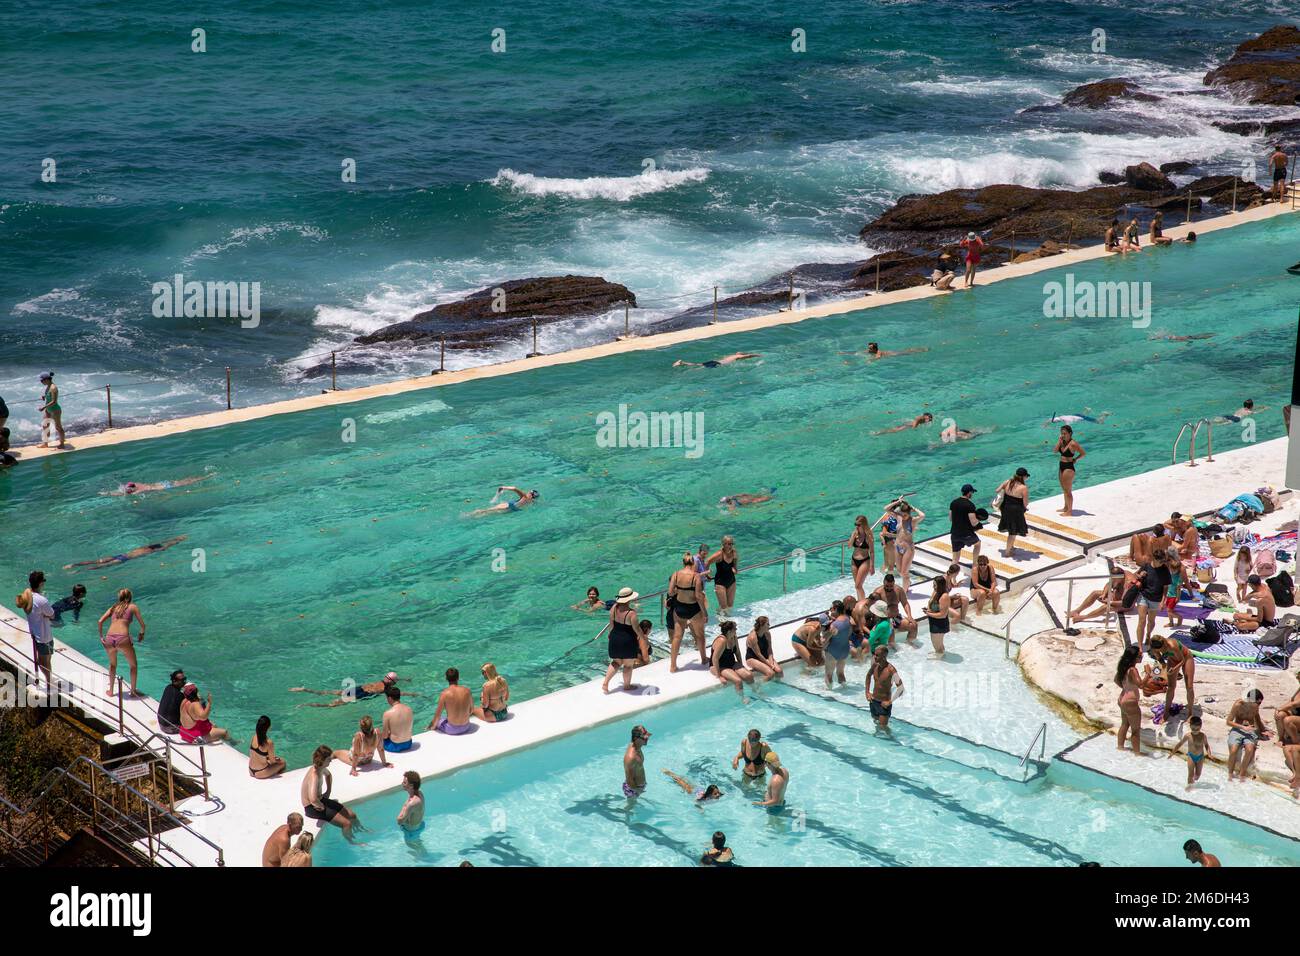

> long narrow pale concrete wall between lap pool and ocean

[{"left": 13, "top": 203, "right": 1294, "bottom": 463}]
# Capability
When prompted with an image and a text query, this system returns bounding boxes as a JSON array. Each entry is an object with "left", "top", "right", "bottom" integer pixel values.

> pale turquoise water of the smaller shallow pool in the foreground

[{"left": 315, "top": 685, "right": 1300, "bottom": 866}]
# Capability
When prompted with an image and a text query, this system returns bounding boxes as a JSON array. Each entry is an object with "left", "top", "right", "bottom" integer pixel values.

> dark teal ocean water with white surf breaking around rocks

[{"left": 0, "top": 0, "right": 1300, "bottom": 440}]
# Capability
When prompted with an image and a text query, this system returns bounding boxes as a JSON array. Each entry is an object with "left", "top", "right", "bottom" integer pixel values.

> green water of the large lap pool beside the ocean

[{"left": 0, "top": 217, "right": 1300, "bottom": 766}]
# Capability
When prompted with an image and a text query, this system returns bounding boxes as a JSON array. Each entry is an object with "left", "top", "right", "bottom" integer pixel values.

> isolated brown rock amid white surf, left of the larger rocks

[{"left": 355, "top": 276, "right": 637, "bottom": 347}]
